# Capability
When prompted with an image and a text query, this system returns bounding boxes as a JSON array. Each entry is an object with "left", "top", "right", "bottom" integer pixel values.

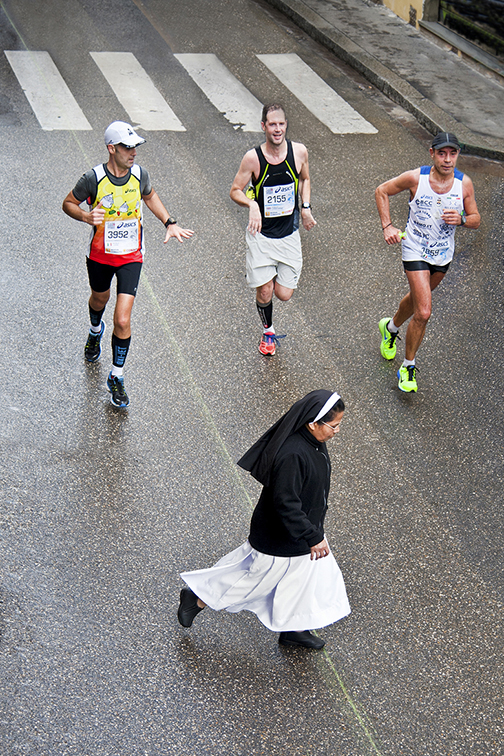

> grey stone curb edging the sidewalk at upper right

[{"left": 266, "top": 0, "right": 504, "bottom": 160}]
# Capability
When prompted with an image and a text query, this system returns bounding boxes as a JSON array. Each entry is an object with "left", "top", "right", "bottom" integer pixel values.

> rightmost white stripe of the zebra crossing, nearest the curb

[{"left": 256, "top": 53, "right": 378, "bottom": 134}]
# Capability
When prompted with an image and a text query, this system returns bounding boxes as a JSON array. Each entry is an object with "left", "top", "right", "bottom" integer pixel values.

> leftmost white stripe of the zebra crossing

[{"left": 5, "top": 50, "right": 92, "bottom": 131}]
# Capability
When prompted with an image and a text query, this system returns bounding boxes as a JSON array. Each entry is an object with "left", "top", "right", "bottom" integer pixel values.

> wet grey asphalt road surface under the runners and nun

[{"left": 0, "top": 0, "right": 504, "bottom": 756}]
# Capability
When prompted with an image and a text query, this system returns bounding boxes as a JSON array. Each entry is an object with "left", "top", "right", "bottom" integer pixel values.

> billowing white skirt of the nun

[{"left": 181, "top": 541, "right": 350, "bottom": 632}]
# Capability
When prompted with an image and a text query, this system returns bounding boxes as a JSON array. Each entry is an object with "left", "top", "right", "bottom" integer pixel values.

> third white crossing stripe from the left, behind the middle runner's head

[{"left": 175, "top": 53, "right": 262, "bottom": 131}]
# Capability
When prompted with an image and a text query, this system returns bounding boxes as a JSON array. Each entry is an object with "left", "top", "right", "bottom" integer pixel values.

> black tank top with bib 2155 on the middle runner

[{"left": 252, "top": 140, "right": 299, "bottom": 239}]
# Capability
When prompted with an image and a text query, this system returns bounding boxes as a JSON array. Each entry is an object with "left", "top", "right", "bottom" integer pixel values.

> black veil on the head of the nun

[{"left": 237, "top": 389, "right": 337, "bottom": 486}]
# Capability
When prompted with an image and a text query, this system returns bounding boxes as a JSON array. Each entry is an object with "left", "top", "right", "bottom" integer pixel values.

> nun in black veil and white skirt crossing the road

[{"left": 178, "top": 389, "right": 350, "bottom": 649}]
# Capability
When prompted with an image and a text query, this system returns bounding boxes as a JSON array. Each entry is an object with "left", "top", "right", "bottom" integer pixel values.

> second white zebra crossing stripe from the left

[{"left": 90, "top": 52, "right": 185, "bottom": 131}]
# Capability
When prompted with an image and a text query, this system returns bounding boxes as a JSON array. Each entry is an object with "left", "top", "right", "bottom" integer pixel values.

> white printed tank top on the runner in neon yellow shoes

[{"left": 402, "top": 165, "right": 464, "bottom": 265}]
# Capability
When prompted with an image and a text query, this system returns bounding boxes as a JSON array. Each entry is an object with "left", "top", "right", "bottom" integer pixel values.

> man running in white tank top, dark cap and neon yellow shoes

[{"left": 375, "top": 132, "right": 480, "bottom": 392}]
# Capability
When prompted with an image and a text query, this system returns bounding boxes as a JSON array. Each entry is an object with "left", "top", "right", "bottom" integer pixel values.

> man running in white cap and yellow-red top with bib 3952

[{"left": 63, "top": 121, "right": 193, "bottom": 408}]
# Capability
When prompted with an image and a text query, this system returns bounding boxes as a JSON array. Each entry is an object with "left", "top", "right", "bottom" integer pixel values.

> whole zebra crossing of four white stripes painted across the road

[{"left": 5, "top": 50, "right": 378, "bottom": 134}]
